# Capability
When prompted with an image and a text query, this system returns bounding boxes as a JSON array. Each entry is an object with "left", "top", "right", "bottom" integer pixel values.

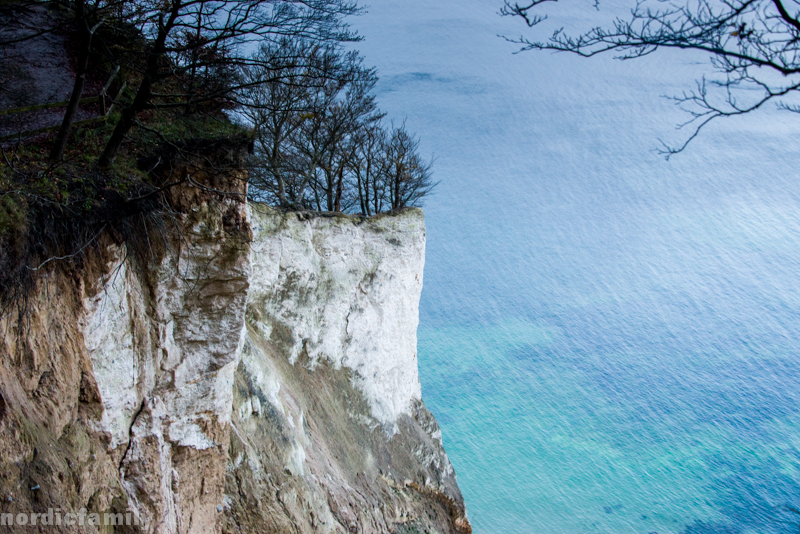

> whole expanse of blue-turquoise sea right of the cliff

[{"left": 356, "top": 0, "right": 800, "bottom": 534}]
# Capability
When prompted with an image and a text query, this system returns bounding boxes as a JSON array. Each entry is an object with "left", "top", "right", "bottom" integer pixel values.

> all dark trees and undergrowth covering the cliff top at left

[{"left": 0, "top": 0, "right": 435, "bottom": 314}]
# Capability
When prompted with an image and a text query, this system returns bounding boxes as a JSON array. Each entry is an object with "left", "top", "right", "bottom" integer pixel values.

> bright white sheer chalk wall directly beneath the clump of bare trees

[{"left": 248, "top": 204, "right": 425, "bottom": 424}]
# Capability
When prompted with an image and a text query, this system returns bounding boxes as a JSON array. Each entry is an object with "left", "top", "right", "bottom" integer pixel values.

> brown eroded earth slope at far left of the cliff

[{"left": 0, "top": 262, "right": 123, "bottom": 533}]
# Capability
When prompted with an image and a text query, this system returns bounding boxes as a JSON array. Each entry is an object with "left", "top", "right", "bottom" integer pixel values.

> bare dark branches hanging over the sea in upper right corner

[{"left": 501, "top": 0, "right": 800, "bottom": 157}]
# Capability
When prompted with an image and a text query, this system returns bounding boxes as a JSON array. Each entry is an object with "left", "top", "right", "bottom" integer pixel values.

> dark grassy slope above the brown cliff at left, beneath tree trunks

[{"left": 0, "top": 107, "right": 247, "bottom": 316}]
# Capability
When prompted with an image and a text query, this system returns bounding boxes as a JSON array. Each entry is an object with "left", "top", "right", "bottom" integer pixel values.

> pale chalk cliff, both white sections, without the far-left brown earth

[{"left": 65, "top": 203, "right": 468, "bottom": 534}]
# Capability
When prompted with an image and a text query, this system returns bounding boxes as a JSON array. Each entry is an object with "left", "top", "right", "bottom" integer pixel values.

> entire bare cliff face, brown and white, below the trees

[{"left": 0, "top": 169, "right": 470, "bottom": 533}]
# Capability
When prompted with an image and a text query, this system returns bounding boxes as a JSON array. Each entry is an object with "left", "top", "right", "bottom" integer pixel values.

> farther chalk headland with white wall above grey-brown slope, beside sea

[{"left": 225, "top": 205, "right": 470, "bottom": 533}]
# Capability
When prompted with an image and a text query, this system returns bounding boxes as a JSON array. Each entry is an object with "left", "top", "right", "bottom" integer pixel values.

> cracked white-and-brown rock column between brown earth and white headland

[{"left": 82, "top": 177, "right": 251, "bottom": 534}]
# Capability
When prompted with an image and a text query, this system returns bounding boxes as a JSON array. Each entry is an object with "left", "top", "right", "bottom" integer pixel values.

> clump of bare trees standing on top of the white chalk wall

[{"left": 241, "top": 42, "right": 435, "bottom": 216}]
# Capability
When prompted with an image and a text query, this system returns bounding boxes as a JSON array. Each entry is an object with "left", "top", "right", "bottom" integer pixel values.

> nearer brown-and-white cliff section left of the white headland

[{"left": 0, "top": 146, "right": 252, "bottom": 533}]
